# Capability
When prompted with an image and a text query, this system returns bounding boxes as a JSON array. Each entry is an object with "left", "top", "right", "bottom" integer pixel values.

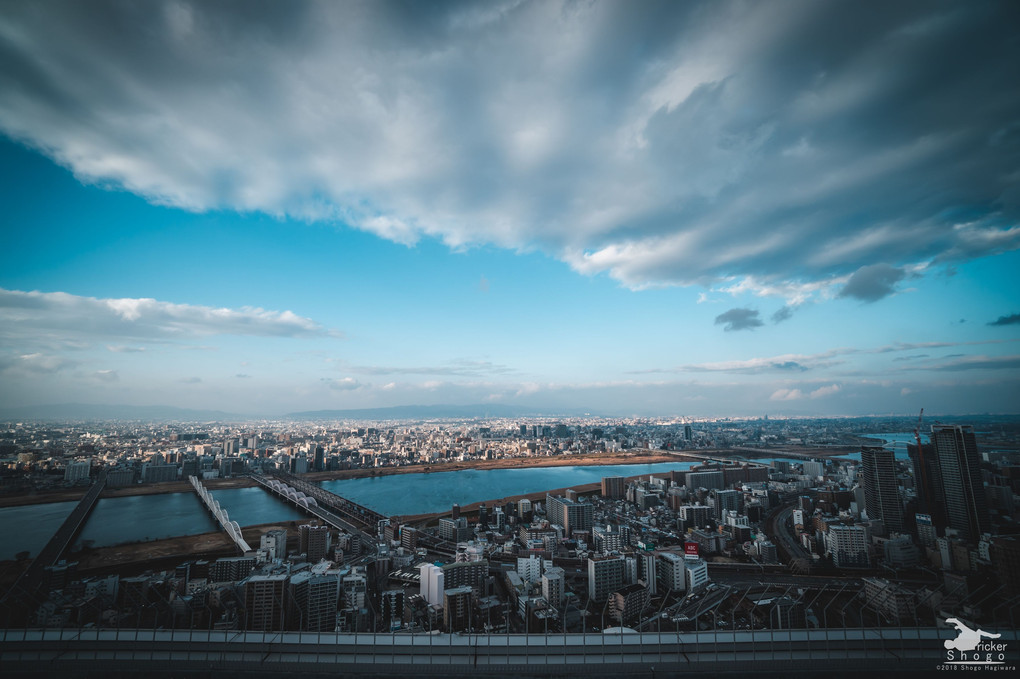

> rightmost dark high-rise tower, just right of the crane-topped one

[{"left": 931, "top": 424, "right": 991, "bottom": 542}]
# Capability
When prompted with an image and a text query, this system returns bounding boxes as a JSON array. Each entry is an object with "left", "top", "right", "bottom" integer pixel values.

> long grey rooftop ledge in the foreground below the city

[{"left": 0, "top": 627, "right": 995, "bottom": 678}]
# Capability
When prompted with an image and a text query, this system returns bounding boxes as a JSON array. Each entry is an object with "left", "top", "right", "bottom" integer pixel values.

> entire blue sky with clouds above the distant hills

[{"left": 0, "top": 0, "right": 1020, "bottom": 417}]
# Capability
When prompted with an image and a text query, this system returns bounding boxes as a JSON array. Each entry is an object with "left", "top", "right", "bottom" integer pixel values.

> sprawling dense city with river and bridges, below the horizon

[{"left": 0, "top": 413, "right": 1020, "bottom": 672}]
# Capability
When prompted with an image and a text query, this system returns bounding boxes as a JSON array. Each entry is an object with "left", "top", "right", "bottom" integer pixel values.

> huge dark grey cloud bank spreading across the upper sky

[{"left": 0, "top": 1, "right": 1020, "bottom": 293}]
